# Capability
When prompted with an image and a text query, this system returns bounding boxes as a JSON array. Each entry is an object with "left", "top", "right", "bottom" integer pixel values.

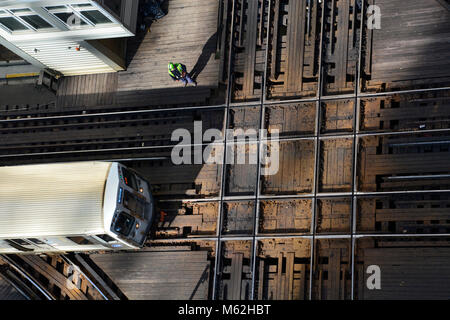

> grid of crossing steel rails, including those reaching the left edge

[{"left": 0, "top": 0, "right": 450, "bottom": 300}]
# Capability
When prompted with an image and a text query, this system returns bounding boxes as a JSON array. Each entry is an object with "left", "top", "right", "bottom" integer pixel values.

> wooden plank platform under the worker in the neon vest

[{"left": 57, "top": 0, "right": 220, "bottom": 109}]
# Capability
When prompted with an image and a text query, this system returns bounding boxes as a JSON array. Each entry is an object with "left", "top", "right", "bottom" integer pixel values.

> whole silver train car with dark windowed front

[{"left": 0, "top": 161, "right": 154, "bottom": 254}]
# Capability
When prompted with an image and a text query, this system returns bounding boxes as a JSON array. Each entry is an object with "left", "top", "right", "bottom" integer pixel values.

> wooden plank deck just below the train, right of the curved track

[{"left": 90, "top": 250, "right": 210, "bottom": 300}]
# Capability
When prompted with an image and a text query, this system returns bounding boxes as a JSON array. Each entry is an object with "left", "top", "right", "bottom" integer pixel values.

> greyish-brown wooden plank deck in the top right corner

[{"left": 372, "top": 0, "right": 450, "bottom": 81}]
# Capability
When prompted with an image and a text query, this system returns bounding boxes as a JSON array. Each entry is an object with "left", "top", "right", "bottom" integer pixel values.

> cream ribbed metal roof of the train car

[{"left": 0, "top": 162, "right": 112, "bottom": 239}]
